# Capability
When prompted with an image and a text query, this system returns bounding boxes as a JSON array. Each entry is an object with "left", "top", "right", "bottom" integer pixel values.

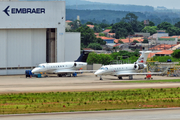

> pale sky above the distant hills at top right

[{"left": 86, "top": 0, "right": 180, "bottom": 9}]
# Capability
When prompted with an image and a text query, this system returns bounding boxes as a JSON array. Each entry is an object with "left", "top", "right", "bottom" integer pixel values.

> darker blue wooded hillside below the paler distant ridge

[{"left": 66, "top": 9, "right": 180, "bottom": 25}]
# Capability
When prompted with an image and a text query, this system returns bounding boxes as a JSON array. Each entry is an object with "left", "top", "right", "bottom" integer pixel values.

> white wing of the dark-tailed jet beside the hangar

[{"left": 54, "top": 69, "right": 96, "bottom": 74}]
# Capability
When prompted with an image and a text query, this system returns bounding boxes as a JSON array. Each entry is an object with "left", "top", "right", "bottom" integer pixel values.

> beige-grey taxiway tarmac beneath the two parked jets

[{"left": 0, "top": 73, "right": 180, "bottom": 93}]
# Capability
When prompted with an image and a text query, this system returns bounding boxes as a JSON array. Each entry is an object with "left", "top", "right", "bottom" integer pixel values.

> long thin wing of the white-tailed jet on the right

[{"left": 116, "top": 72, "right": 163, "bottom": 76}]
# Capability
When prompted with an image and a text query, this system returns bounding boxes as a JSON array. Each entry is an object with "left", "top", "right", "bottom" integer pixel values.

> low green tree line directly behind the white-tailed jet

[{"left": 87, "top": 50, "right": 180, "bottom": 65}]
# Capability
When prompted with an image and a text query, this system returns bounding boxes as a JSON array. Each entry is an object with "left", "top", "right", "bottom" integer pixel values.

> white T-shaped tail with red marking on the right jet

[{"left": 136, "top": 51, "right": 152, "bottom": 64}]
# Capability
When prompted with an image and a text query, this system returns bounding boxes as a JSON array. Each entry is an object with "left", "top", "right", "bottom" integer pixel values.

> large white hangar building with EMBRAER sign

[{"left": 0, "top": 1, "right": 80, "bottom": 75}]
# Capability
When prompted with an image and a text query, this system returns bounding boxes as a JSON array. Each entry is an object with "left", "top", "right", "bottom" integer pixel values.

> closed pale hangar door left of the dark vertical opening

[{"left": 0, "top": 29, "right": 46, "bottom": 74}]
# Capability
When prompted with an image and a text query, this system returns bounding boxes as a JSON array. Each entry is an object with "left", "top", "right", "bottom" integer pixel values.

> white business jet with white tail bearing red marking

[{"left": 94, "top": 51, "right": 161, "bottom": 80}]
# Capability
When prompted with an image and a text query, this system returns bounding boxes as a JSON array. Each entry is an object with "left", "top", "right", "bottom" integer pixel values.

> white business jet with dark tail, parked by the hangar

[{"left": 31, "top": 51, "right": 92, "bottom": 77}]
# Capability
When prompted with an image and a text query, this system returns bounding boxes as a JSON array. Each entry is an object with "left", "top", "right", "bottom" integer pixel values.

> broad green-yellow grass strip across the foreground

[{"left": 0, "top": 88, "right": 180, "bottom": 114}]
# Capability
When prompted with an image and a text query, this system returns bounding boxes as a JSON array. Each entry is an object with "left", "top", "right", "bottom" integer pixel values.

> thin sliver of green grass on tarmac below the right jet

[{"left": 114, "top": 79, "right": 180, "bottom": 83}]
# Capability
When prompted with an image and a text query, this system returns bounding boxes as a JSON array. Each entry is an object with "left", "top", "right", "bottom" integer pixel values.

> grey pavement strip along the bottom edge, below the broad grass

[{"left": 0, "top": 108, "right": 180, "bottom": 120}]
